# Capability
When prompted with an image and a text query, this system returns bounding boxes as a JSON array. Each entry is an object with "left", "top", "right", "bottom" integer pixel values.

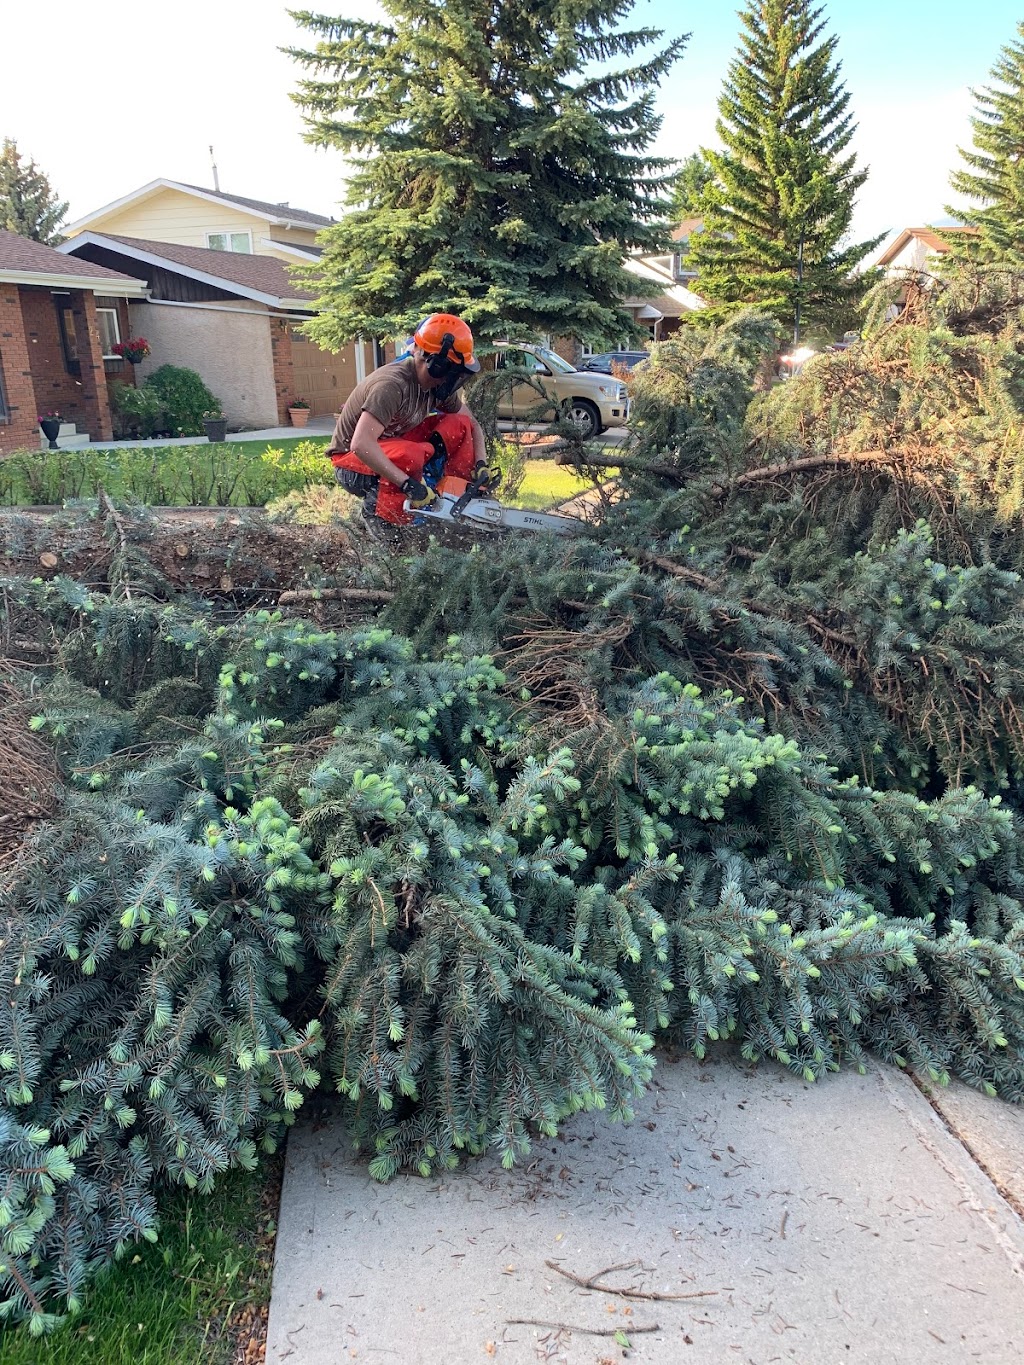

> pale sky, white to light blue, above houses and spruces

[{"left": 0, "top": 0, "right": 1024, "bottom": 256}]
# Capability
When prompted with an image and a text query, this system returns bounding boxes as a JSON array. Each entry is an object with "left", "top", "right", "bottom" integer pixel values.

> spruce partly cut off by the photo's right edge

[{"left": 946, "top": 22, "right": 1024, "bottom": 262}]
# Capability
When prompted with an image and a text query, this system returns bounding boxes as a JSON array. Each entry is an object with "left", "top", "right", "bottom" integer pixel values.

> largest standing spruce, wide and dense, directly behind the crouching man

[{"left": 292, "top": 0, "right": 685, "bottom": 348}]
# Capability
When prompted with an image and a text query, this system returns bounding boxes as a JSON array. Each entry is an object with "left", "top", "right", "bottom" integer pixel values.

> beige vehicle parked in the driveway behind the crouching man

[{"left": 494, "top": 341, "right": 629, "bottom": 440}]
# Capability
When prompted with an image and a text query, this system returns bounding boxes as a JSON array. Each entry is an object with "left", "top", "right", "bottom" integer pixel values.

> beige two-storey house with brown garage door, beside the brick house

[{"left": 60, "top": 180, "right": 384, "bottom": 430}]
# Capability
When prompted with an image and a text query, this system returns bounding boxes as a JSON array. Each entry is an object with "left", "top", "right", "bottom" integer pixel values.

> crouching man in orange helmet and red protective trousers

[{"left": 328, "top": 313, "right": 496, "bottom": 526}]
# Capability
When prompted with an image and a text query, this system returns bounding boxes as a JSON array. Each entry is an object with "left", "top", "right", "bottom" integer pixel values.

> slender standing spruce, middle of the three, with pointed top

[{"left": 688, "top": 0, "right": 881, "bottom": 334}]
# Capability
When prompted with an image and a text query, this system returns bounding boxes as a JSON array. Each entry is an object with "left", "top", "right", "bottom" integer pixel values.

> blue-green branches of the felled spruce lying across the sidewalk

[{"left": 0, "top": 263, "right": 1024, "bottom": 1330}]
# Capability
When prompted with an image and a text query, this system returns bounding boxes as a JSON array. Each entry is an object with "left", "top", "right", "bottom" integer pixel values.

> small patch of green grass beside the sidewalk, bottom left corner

[{"left": 0, "top": 1170, "right": 276, "bottom": 1365}]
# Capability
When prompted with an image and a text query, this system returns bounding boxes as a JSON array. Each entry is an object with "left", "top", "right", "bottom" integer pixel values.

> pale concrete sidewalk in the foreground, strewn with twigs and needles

[{"left": 266, "top": 1050, "right": 1024, "bottom": 1365}]
